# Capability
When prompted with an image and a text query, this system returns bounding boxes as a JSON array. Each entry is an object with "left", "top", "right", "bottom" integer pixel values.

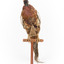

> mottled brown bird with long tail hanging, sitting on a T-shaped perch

[{"left": 20, "top": 0, "right": 41, "bottom": 62}]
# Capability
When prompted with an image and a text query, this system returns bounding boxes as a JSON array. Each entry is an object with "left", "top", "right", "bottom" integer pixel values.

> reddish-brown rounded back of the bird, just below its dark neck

[{"left": 21, "top": 5, "right": 37, "bottom": 25}]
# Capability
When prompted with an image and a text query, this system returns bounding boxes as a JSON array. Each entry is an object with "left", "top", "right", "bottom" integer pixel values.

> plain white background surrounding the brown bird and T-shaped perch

[{"left": 0, "top": 0, "right": 64, "bottom": 64}]
